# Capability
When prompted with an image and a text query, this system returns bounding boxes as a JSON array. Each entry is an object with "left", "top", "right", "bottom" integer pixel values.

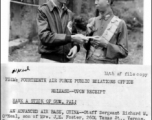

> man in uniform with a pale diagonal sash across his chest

[{"left": 86, "top": 0, "right": 128, "bottom": 64}]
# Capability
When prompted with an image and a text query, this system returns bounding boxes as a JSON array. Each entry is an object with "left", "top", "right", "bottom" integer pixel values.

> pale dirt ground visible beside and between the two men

[{"left": 9, "top": 31, "right": 143, "bottom": 64}]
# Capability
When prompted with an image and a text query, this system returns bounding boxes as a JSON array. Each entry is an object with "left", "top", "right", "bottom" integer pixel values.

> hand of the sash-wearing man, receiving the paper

[{"left": 91, "top": 36, "right": 109, "bottom": 48}]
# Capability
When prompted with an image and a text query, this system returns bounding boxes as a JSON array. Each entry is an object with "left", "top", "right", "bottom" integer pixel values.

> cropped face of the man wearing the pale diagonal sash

[{"left": 95, "top": 0, "right": 109, "bottom": 11}]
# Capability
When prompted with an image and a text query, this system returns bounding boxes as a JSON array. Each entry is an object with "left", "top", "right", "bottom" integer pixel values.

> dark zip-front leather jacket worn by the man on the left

[{"left": 37, "top": 1, "right": 76, "bottom": 62}]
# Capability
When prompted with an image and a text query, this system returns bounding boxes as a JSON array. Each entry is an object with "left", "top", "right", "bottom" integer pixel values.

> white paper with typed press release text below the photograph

[{"left": 1, "top": 63, "right": 151, "bottom": 120}]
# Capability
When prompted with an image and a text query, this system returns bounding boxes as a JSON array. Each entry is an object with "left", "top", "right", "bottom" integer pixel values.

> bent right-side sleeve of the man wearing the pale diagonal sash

[{"left": 106, "top": 20, "right": 128, "bottom": 59}]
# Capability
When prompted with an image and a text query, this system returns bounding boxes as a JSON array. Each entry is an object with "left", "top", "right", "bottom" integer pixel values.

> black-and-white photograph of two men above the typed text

[{"left": 8, "top": 0, "right": 145, "bottom": 65}]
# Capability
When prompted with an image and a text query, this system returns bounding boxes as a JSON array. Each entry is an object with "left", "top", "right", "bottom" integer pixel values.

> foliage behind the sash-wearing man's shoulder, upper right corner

[{"left": 112, "top": 1, "right": 143, "bottom": 30}]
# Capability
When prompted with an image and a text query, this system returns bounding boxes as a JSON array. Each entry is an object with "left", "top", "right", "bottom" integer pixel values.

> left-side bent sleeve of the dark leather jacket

[{"left": 37, "top": 8, "right": 71, "bottom": 46}]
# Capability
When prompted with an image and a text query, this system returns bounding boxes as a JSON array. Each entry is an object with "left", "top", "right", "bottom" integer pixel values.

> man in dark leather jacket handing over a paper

[{"left": 37, "top": 0, "right": 86, "bottom": 63}]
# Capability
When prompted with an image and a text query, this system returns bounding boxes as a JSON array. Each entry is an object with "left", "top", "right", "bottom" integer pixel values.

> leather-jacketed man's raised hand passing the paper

[{"left": 71, "top": 34, "right": 89, "bottom": 44}]
